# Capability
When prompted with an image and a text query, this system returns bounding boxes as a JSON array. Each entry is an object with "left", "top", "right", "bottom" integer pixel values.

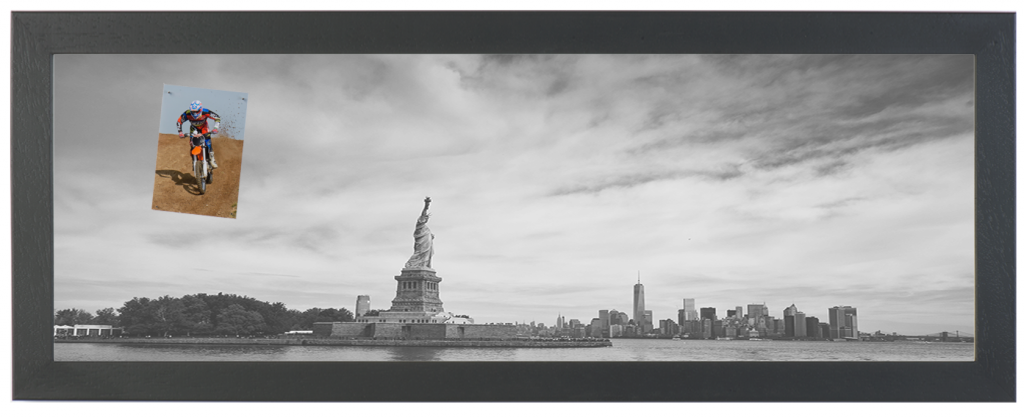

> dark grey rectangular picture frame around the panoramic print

[{"left": 11, "top": 12, "right": 1016, "bottom": 402}]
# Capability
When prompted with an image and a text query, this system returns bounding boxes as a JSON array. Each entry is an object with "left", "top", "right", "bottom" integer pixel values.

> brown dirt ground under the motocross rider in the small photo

[{"left": 153, "top": 134, "right": 243, "bottom": 218}]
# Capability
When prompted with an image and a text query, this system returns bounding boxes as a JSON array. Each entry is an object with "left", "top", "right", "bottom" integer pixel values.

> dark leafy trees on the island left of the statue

[{"left": 59, "top": 293, "right": 354, "bottom": 336}]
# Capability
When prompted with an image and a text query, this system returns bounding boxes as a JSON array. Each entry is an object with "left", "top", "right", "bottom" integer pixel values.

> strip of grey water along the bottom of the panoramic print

[{"left": 53, "top": 339, "right": 974, "bottom": 362}]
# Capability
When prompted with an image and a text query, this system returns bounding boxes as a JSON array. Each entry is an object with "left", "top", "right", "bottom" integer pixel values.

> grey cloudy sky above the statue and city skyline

[{"left": 54, "top": 55, "right": 974, "bottom": 333}]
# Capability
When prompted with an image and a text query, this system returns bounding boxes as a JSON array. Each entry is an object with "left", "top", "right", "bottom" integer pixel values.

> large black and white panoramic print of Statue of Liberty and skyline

[{"left": 53, "top": 54, "right": 976, "bottom": 362}]
